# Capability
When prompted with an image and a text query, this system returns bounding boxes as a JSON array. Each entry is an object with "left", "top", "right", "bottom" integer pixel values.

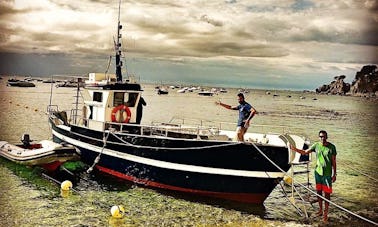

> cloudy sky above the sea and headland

[{"left": 0, "top": 0, "right": 378, "bottom": 90}]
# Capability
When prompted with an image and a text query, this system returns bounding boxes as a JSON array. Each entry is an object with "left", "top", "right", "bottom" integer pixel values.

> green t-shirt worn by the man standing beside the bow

[{"left": 311, "top": 142, "right": 337, "bottom": 176}]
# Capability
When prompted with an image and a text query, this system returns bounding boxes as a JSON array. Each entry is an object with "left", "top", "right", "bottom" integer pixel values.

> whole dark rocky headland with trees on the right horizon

[{"left": 316, "top": 65, "right": 378, "bottom": 97}]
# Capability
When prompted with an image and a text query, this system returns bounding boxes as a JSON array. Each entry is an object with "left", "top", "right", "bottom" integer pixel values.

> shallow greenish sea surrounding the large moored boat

[{"left": 0, "top": 78, "right": 378, "bottom": 226}]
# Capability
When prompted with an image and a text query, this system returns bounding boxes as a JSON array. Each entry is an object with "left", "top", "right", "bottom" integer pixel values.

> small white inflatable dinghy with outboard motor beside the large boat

[{"left": 0, "top": 134, "right": 79, "bottom": 170}]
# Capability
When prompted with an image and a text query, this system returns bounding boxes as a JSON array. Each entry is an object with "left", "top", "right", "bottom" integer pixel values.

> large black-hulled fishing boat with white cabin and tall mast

[{"left": 48, "top": 1, "right": 307, "bottom": 204}]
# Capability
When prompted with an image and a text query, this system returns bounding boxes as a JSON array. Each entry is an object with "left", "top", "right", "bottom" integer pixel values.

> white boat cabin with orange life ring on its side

[{"left": 81, "top": 73, "right": 143, "bottom": 130}]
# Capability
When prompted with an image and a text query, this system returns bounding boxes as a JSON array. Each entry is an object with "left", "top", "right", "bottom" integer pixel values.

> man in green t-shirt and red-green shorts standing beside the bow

[{"left": 290, "top": 130, "right": 337, "bottom": 222}]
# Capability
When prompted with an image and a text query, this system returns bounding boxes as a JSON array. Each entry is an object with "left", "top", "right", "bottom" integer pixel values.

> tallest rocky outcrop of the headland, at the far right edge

[{"left": 350, "top": 65, "right": 378, "bottom": 95}]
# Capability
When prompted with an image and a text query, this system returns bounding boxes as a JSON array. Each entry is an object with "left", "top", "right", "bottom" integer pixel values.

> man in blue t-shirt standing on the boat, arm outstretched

[{"left": 216, "top": 93, "right": 257, "bottom": 142}]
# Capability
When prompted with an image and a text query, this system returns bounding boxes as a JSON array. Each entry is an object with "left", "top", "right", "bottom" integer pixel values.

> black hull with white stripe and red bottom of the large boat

[{"left": 52, "top": 121, "right": 290, "bottom": 204}]
